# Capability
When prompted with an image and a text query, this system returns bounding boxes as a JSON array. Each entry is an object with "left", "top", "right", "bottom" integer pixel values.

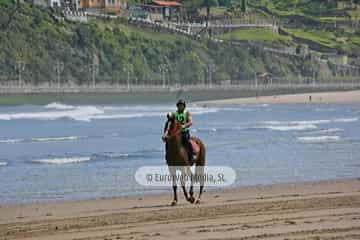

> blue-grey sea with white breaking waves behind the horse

[{"left": 0, "top": 102, "right": 360, "bottom": 205}]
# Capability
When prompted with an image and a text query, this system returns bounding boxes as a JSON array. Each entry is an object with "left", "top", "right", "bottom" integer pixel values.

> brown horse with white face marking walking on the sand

[{"left": 162, "top": 117, "right": 205, "bottom": 206}]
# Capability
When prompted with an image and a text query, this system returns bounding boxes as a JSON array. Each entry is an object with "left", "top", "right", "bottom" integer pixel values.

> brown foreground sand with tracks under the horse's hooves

[{"left": 0, "top": 179, "right": 360, "bottom": 240}]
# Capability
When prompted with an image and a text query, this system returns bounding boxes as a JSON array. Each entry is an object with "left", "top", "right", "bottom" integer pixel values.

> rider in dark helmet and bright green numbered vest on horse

[{"left": 168, "top": 99, "right": 195, "bottom": 165}]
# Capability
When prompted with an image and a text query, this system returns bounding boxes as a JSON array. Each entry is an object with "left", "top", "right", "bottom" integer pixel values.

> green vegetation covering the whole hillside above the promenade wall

[{"left": 0, "top": 0, "right": 360, "bottom": 84}]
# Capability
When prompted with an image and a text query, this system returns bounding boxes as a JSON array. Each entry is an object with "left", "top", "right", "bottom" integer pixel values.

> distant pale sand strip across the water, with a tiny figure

[{"left": 195, "top": 90, "right": 360, "bottom": 105}]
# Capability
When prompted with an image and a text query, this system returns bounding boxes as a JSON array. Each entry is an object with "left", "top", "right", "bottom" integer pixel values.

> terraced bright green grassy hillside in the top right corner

[{"left": 222, "top": 0, "right": 360, "bottom": 58}]
